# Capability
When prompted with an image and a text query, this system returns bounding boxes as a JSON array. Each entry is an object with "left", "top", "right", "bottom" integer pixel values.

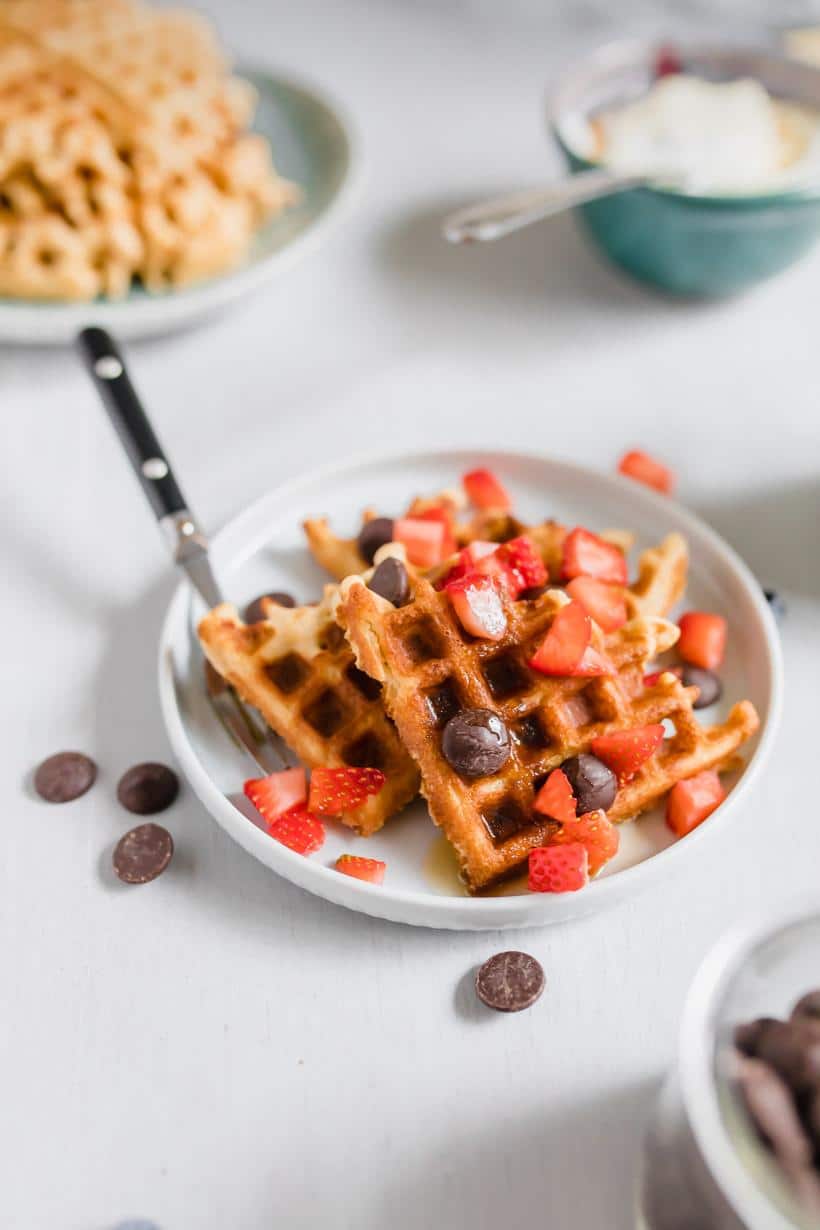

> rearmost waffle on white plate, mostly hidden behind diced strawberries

[{"left": 304, "top": 509, "right": 688, "bottom": 617}]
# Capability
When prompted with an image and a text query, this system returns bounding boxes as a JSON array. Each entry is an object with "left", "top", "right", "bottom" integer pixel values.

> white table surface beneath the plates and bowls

[{"left": 6, "top": 0, "right": 820, "bottom": 1230}]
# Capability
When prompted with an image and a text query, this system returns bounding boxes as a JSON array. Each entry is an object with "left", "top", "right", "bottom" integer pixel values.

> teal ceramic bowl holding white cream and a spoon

[{"left": 548, "top": 42, "right": 820, "bottom": 298}]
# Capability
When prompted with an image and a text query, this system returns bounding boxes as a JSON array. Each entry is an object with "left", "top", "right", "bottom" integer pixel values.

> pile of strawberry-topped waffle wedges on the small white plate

[{"left": 200, "top": 499, "right": 757, "bottom": 892}]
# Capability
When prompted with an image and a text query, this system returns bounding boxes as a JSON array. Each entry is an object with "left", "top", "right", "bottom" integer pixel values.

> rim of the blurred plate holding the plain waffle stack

[{"left": 0, "top": 60, "right": 363, "bottom": 346}]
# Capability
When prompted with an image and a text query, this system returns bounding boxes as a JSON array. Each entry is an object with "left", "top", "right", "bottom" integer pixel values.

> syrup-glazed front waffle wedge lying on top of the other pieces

[{"left": 336, "top": 577, "right": 757, "bottom": 892}]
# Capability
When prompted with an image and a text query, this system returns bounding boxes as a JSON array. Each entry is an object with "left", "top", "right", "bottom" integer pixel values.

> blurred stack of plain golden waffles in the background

[{"left": 0, "top": 0, "right": 296, "bottom": 300}]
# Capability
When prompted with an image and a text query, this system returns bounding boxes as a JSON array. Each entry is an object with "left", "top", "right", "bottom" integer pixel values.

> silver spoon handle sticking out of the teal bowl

[{"left": 441, "top": 170, "right": 647, "bottom": 244}]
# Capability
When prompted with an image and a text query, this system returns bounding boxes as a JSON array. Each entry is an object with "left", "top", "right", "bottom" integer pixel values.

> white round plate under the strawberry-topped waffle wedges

[{"left": 160, "top": 451, "right": 782, "bottom": 930}]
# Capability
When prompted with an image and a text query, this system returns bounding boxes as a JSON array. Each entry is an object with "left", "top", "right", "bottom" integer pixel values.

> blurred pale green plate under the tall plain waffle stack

[{"left": 0, "top": 68, "right": 353, "bottom": 346}]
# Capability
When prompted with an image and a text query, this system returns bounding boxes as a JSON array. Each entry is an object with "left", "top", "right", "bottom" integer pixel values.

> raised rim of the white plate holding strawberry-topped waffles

[{"left": 159, "top": 448, "right": 784, "bottom": 931}]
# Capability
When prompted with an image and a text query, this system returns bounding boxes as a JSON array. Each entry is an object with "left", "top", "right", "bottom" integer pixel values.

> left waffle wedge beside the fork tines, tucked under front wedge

[{"left": 199, "top": 587, "right": 419, "bottom": 835}]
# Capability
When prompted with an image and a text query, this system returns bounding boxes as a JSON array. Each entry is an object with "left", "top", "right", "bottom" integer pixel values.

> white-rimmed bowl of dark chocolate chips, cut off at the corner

[{"left": 638, "top": 900, "right": 820, "bottom": 1230}]
